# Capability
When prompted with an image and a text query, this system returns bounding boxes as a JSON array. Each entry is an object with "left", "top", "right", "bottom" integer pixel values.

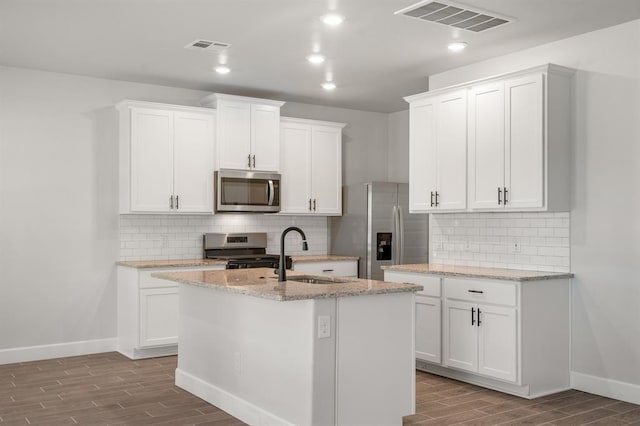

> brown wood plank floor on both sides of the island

[{"left": 0, "top": 352, "right": 640, "bottom": 426}]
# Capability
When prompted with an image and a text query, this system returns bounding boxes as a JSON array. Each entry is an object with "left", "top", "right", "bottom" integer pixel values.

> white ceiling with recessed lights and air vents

[{"left": 0, "top": 0, "right": 640, "bottom": 112}]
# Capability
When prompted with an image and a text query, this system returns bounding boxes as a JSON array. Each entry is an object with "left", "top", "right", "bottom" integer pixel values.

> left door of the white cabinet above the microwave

[{"left": 216, "top": 101, "right": 251, "bottom": 170}]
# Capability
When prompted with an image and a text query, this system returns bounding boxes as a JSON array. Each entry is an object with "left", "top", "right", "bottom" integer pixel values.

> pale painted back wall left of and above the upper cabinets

[{"left": 0, "top": 67, "right": 387, "bottom": 354}]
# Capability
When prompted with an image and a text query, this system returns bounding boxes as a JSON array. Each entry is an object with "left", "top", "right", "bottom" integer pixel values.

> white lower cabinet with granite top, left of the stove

[{"left": 118, "top": 265, "right": 224, "bottom": 359}]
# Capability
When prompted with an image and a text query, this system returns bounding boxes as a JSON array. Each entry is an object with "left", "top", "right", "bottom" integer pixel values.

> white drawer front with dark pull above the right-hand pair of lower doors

[{"left": 444, "top": 278, "right": 517, "bottom": 306}]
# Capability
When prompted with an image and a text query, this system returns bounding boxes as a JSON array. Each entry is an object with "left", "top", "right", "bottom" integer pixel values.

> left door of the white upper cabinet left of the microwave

[{"left": 130, "top": 108, "right": 173, "bottom": 212}]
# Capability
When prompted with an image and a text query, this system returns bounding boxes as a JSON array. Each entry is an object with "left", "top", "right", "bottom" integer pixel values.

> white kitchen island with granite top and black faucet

[{"left": 154, "top": 268, "right": 422, "bottom": 425}]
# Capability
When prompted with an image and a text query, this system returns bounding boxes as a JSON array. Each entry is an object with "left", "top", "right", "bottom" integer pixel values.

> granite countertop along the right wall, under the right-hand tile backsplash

[{"left": 382, "top": 263, "right": 573, "bottom": 281}]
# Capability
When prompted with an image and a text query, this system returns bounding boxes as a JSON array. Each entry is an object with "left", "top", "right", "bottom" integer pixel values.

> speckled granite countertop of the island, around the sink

[{"left": 151, "top": 268, "right": 422, "bottom": 301}]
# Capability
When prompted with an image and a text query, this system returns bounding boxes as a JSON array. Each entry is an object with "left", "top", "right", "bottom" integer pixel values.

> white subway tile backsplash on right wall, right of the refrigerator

[{"left": 429, "top": 212, "right": 571, "bottom": 272}]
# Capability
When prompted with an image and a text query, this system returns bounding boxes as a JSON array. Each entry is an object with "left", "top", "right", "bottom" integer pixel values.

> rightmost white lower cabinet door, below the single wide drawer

[{"left": 478, "top": 305, "right": 518, "bottom": 382}]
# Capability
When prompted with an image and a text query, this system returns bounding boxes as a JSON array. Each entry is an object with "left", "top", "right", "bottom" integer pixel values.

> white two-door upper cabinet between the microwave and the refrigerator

[{"left": 280, "top": 117, "right": 345, "bottom": 216}]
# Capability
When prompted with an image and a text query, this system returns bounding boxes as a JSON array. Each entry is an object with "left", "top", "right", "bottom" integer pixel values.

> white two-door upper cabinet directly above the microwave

[{"left": 201, "top": 93, "right": 284, "bottom": 172}]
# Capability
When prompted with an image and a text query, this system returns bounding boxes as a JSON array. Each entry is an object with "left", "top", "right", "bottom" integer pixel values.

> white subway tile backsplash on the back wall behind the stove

[{"left": 120, "top": 213, "right": 328, "bottom": 260}]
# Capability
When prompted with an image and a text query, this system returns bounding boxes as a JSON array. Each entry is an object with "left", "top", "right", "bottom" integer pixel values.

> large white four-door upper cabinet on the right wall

[{"left": 406, "top": 64, "right": 573, "bottom": 212}]
